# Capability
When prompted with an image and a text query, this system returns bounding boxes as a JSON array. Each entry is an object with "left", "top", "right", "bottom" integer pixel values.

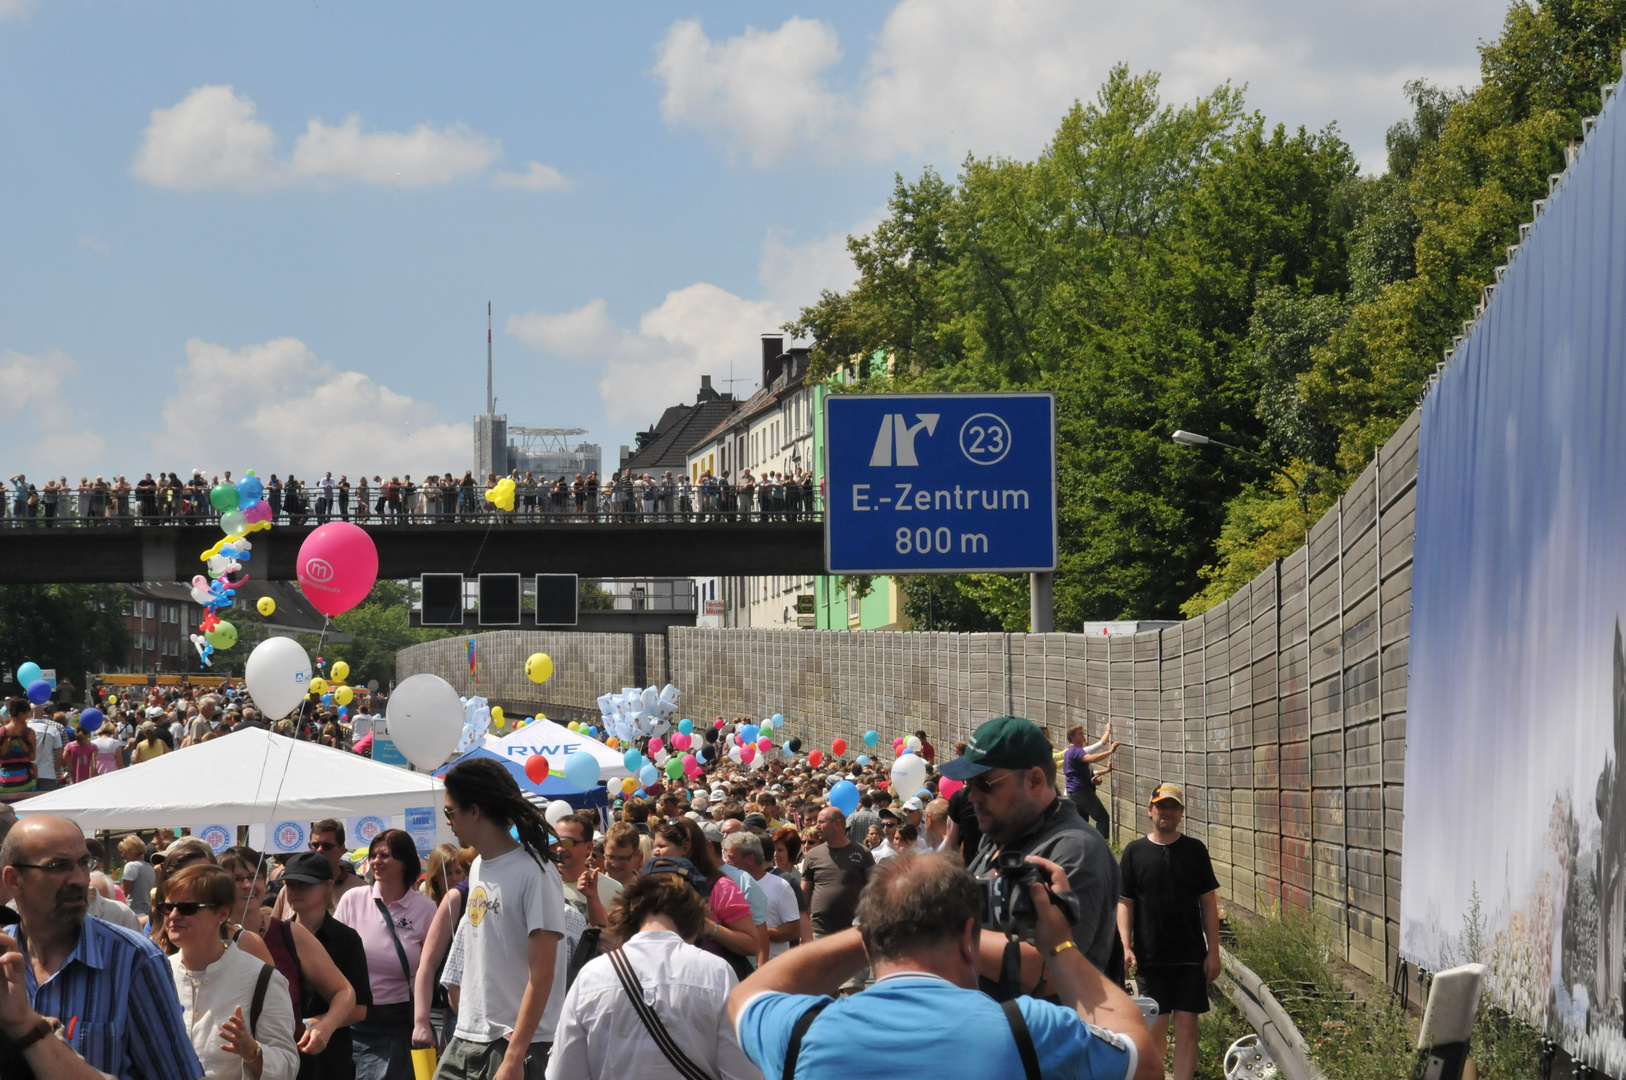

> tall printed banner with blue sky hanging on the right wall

[{"left": 1400, "top": 78, "right": 1626, "bottom": 1075}]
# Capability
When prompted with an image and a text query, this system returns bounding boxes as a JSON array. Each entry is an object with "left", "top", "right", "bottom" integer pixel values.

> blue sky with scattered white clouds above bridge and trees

[{"left": 0, "top": 0, "right": 1504, "bottom": 480}]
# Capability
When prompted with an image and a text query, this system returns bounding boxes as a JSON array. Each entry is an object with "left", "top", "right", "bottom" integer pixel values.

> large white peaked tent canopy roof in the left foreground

[{"left": 13, "top": 729, "right": 444, "bottom": 833}]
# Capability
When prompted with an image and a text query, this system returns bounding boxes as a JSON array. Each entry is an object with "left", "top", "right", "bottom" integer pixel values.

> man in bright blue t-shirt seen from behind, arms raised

[{"left": 728, "top": 854, "right": 1163, "bottom": 1080}]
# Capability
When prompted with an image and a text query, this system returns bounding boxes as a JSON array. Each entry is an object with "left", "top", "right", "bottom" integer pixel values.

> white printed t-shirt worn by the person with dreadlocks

[{"left": 457, "top": 847, "right": 569, "bottom": 1043}]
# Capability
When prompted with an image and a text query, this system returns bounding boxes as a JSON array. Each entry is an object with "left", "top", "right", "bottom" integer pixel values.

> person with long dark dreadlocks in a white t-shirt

[{"left": 434, "top": 758, "right": 569, "bottom": 1080}]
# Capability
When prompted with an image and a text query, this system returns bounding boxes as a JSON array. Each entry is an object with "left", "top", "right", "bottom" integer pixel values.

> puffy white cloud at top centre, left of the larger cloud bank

[{"left": 655, "top": 18, "right": 841, "bottom": 164}]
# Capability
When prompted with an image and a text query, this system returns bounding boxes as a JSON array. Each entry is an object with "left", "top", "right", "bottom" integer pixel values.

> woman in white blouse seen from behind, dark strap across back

[{"left": 546, "top": 859, "right": 761, "bottom": 1080}]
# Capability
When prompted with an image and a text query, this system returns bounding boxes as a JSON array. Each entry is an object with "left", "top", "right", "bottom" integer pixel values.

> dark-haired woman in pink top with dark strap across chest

[{"left": 333, "top": 830, "right": 434, "bottom": 1080}]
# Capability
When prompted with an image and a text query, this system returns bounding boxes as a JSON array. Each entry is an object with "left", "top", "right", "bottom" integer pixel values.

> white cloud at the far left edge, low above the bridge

[{"left": 0, "top": 351, "right": 107, "bottom": 465}]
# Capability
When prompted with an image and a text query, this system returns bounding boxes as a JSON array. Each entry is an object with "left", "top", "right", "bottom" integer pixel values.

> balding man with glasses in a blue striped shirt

[{"left": 0, "top": 815, "right": 203, "bottom": 1080}]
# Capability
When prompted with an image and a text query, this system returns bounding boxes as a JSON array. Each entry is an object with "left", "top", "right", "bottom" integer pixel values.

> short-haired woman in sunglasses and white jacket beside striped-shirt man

[{"left": 156, "top": 864, "right": 299, "bottom": 1080}]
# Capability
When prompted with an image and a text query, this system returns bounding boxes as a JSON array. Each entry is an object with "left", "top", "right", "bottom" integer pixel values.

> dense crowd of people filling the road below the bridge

[{"left": 0, "top": 690, "right": 1220, "bottom": 1080}]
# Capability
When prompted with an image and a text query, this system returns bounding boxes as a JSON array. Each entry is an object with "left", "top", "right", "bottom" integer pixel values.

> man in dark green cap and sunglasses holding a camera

[{"left": 941, "top": 716, "right": 1122, "bottom": 995}]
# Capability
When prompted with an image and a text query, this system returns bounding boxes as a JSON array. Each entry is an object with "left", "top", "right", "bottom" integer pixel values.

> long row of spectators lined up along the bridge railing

[{"left": 0, "top": 468, "right": 821, "bottom": 529}]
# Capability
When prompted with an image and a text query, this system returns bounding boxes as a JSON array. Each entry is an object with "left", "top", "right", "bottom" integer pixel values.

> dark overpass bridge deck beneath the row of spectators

[{"left": 0, "top": 516, "right": 824, "bottom": 586}]
